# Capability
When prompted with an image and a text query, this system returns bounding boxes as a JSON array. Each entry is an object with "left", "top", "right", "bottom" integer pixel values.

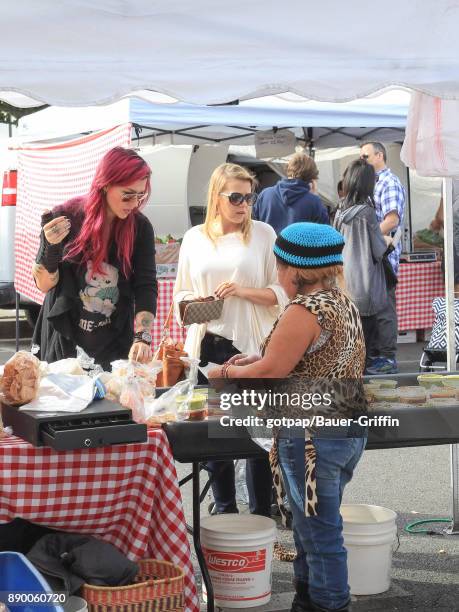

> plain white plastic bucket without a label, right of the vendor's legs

[{"left": 341, "top": 504, "right": 397, "bottom": 595}]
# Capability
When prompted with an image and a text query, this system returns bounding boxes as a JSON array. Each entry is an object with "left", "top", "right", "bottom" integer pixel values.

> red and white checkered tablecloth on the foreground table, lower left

[{"left": 0, "top": 429, "right": 199, "bottom": 612}]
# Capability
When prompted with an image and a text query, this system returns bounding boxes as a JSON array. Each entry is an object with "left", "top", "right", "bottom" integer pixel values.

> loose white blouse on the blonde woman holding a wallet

[{"left": 174, "top": 221, "right": 288, "bottom": 358}]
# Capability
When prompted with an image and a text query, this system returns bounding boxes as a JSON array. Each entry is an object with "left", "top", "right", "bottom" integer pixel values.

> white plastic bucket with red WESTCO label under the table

[{"left": 201, "top": 514, "right": 276, "bottom": 608}]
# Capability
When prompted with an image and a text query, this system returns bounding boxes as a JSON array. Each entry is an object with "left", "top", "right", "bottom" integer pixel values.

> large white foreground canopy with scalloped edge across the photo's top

[{"left": 0, "top": 0, "right": 459, "bottom": 106}]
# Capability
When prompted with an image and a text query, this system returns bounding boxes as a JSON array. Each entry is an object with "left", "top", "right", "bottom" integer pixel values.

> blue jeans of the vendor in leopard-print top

[{"left": 279, "top": 437, "right": 366, "bottom": 610}]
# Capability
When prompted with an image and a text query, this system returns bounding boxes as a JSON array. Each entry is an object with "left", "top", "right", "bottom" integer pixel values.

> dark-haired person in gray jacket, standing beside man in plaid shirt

[{"left": 334, "top": 159, "right": 388, "bottom": 355}]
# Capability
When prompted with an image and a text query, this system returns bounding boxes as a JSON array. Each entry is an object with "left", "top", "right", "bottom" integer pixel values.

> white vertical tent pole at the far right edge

[{"left": 443, "top": 178, "right": 459, "bottom": 534}]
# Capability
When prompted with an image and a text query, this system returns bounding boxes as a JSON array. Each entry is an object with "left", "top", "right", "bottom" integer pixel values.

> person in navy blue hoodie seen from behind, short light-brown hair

[{"left": 252, "top": 153, "right": 330, "bottom": 234}]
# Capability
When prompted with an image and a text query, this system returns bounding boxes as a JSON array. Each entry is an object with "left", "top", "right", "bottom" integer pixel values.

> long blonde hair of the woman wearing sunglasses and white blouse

[{"left": 203, "top": 164, "right": 256, "bottom": 244}]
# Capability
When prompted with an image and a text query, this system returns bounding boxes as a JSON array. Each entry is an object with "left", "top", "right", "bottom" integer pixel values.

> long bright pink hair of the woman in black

[{"left": 65, "top": 147, "right": 151, "bottom": 278}]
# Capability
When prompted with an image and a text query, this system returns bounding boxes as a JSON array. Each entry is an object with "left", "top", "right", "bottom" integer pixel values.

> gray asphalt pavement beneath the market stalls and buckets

[{"left": 0, "top": 317, "right": 459, "bottom": 612}]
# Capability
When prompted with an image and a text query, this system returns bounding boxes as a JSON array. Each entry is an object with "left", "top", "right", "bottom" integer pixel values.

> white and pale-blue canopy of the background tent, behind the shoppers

[{"left": 18, "top": 91, "right": 410, "bottom": 148}]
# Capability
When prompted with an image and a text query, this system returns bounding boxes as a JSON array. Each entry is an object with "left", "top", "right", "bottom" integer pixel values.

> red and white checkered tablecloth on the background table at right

[{"left": 396, "top": 261, "right": 445, "bottom": 331}]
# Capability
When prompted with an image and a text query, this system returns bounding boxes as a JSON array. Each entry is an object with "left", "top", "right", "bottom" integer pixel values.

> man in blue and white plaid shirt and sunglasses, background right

[{"left": 360, "top": 142, "right": 405, "bottom": 374}]
